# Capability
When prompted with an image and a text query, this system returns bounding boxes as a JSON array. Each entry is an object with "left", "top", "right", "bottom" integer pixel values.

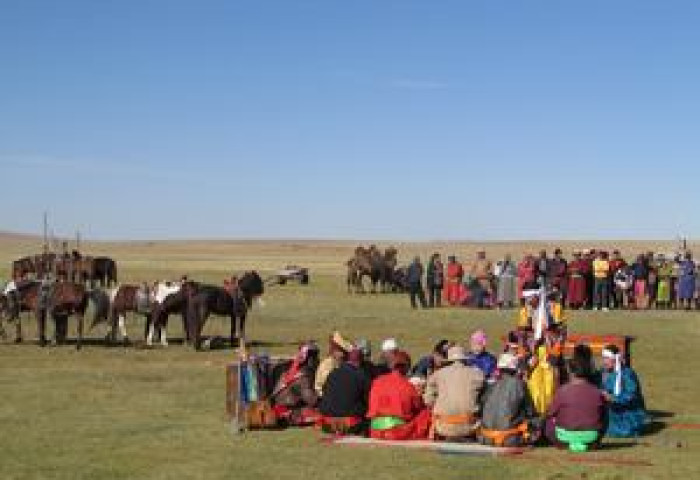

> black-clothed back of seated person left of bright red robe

[{"left": 319, "top": 363, "right": 370, "bottom": 417}]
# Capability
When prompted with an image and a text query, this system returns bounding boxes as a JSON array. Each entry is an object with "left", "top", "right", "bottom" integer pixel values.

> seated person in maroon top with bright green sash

[{"left": 545, "top": 357, "right": 605, "bottom": 452}]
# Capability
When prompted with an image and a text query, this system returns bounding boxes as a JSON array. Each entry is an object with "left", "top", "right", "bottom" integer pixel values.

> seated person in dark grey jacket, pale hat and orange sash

[{"left": 478, "top": 353, "right": 540, "bottom": 447}]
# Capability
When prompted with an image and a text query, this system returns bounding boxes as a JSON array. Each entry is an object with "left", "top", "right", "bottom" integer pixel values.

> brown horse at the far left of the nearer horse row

[{"left": 0, "top": 281, "right": 89, "bottom": 349}]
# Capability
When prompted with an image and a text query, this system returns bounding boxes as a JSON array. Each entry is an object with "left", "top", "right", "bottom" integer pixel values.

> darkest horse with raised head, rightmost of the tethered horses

[{"left": 187, "top": 271, "right": 265, "bottom": 349}]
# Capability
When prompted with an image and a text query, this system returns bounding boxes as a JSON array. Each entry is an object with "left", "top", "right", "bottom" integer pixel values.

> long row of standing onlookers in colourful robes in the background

[{"left": 407, "top": 249, "right": 700, "bottom": 311}]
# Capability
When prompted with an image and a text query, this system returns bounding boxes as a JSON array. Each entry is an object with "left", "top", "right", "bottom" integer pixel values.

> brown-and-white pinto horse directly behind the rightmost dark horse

[{"left": 145, "top": 281, "right": 200, "bottom": 347}]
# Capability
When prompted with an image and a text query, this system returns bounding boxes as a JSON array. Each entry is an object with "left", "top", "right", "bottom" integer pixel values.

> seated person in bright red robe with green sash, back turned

[{"left": 367, "top": 351, "right": 431, "bottom": 440}]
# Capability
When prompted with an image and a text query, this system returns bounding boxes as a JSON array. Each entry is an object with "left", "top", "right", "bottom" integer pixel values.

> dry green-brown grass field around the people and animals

[{"left": 0, "top": 235, "right": 700, "bottom": 480}]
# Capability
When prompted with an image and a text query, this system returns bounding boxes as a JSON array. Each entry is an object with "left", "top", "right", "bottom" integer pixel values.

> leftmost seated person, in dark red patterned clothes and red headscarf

[{"left": 270, "top": 344, "right": 318, "bottom": 426}]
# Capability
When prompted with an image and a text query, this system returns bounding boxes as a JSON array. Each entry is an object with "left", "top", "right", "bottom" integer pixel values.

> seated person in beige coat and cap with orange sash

[{"left": 423, "top": 346, "right": 484, "bottom": 440}]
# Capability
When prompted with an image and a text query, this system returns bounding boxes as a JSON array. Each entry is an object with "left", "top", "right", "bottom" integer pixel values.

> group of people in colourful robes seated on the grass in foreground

[{"left": 271, "top": 288, "right": 647, "bottom": 451}]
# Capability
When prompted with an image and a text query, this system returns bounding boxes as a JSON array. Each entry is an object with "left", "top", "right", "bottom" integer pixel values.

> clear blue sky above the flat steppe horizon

[{"left": 0, "top": 0, "right": 700, "bottom": 240}]
